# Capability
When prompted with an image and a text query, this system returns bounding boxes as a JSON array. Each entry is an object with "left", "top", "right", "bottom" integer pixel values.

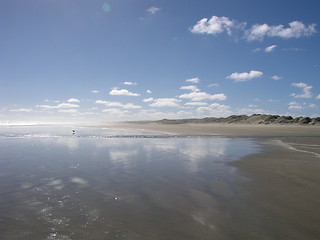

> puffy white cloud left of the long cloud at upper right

[{"left": 190, "top": 16, "right": 236, "bottom": 35}]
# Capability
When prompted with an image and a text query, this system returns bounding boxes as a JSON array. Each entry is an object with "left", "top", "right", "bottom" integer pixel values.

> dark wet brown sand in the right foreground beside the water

[{"left": 231, "top": 138, "right": 320, "bottom": 239}]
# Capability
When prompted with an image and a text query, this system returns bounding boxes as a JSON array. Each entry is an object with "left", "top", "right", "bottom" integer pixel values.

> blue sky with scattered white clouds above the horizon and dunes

[{"left": 0, "top": 0, "right": 320, "bottom": 124}]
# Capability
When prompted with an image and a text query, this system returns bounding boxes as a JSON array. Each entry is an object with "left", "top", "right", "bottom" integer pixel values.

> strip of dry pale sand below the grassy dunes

[{"left": 106, "top": 123, "right": 320, "bottom": 137}]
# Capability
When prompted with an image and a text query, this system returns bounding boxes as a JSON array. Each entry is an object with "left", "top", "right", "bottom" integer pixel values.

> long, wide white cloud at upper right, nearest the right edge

[{"left": 245, "top": 21, "right": 317, "bottom": 41}]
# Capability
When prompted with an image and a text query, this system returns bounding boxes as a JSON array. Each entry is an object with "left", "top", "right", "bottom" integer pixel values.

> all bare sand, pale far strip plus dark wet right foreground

[{"left": 102, "top": 123, "right": 320, "bottom": 240}]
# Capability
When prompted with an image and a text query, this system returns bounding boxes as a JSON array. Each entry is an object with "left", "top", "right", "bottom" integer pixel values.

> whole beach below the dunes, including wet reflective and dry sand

[{"left": 0, "top": 123, "right": 320, "bottom": 240}]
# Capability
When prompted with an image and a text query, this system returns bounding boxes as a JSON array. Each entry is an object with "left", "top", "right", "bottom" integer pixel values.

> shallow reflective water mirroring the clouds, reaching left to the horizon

[{"left": 0, "top": 126, "right": 260, "bottom": 240}]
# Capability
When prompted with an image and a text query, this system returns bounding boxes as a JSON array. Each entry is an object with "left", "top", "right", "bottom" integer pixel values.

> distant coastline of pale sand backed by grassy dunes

[{"left": 101, "top": 114, "right": 320, "bottom": 137}]
